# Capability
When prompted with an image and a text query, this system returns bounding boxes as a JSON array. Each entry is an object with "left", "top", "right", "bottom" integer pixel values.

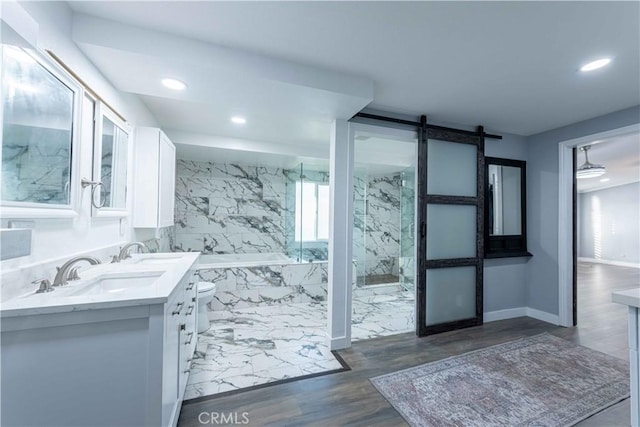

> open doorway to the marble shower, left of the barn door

[{"left": 351, "top": 126, "right": 417, "bottom": 341}]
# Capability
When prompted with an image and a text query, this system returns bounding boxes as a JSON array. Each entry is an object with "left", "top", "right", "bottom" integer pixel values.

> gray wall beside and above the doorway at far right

[{"left": 526, "top": 106, "right": 640, "bottom": 314}]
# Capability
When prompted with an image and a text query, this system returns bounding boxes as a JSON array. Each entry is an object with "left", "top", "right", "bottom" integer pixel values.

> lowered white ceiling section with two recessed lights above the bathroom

[{"left": 73, "top": 10, "right": 373, "bottom": 155}]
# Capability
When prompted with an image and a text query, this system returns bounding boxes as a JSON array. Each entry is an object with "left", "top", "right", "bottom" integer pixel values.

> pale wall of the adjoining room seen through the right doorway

[{"left": 578, "top": 182, "right": 640, "bottom": 263}]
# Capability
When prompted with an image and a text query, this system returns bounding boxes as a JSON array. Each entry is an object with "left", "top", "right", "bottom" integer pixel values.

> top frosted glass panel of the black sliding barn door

[{"left": 427, "top": 139, "right": 478, "bottom": 197}]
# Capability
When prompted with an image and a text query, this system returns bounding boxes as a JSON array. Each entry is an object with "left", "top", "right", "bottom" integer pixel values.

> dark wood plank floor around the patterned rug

[{"left": 178, "top": 264, "right": 640, "bottom": 427}]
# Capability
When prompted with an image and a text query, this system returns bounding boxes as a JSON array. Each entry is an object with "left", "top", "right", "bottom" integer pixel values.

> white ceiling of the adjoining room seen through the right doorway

[{"left": 578, "top": 133, "right": 640, "bottom": 193}]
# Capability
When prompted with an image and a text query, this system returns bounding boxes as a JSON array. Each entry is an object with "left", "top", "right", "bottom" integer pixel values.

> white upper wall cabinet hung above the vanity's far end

[{"left": 133, "top": 127, "right": 176, "bottom": 228}]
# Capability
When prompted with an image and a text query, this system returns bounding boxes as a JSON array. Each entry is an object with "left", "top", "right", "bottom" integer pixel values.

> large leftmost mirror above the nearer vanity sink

[{"left": 1, "top": 44, "right": 80, "bottom": 212}]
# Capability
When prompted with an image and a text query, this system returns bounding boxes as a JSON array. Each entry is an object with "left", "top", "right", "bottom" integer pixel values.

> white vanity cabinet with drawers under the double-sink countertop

[{"left": 0, "top": 253, "right": 198, "bottom": 427}]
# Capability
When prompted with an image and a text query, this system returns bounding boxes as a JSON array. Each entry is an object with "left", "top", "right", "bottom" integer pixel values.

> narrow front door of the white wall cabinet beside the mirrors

[{"left": 158, "top": 132, "right": 176, "bottom": 227}]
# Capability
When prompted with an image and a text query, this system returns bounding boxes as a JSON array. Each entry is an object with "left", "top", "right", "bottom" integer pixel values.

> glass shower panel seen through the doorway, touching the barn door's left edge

[{"left": 399, "top": 167, "right": 416, "bottom": 290}]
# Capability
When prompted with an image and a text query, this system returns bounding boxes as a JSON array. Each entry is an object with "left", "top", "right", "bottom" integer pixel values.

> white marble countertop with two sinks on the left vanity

[{"left": 0, "top": 252, "right": 200, "bottom": 318}]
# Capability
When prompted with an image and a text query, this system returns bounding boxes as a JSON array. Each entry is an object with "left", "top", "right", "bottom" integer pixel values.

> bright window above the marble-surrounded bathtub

[{"left": 295, "top": 181, "right": 329, "bottom": 242}]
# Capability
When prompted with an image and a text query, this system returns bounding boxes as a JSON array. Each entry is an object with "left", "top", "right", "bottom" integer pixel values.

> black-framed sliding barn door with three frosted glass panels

[{"left": 416, "top": 126, "right": 485, "bottom": 336}]
